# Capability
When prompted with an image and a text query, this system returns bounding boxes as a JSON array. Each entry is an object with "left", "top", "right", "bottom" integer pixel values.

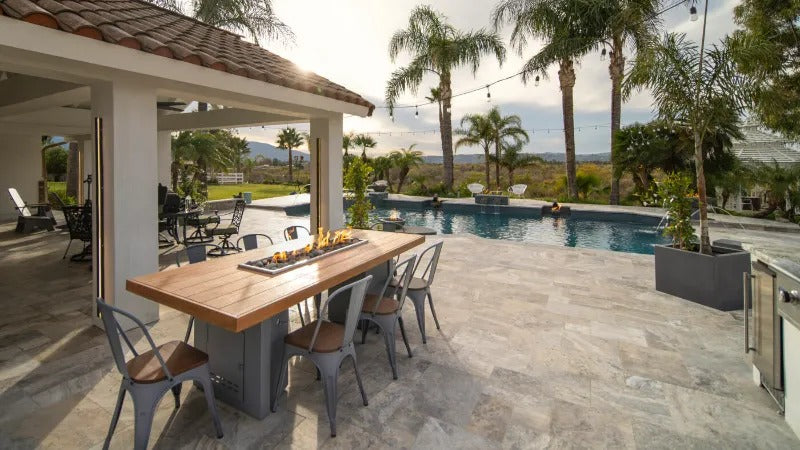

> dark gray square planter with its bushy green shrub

[{"left": 655, "top": 174, "right": 750, "bottom": 311}]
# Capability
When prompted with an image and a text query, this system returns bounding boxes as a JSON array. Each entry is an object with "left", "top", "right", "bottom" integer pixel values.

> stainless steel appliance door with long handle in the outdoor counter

[{"left": 744, "top": 261, "right": 784, "bottom": 410}]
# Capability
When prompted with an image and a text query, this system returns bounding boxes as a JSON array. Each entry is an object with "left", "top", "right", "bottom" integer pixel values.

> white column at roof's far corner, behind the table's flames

[{"left": 309, "top": 114, "right": 344, "bottom": 233}]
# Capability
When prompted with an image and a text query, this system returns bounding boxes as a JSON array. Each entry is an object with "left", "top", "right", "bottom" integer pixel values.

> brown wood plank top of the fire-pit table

[{"left": 126, "top": 230, "right": 425, "bottom": 332}]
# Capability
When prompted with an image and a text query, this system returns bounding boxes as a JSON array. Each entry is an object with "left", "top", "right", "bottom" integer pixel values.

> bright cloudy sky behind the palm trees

[{"left": 234, "top": 0, "right": 738, "bottom": 156}]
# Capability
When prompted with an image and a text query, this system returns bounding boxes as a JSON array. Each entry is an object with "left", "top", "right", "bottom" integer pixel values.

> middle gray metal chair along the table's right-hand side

[{"left": 359, "top": 255, "right": 417, "bottom": 380}]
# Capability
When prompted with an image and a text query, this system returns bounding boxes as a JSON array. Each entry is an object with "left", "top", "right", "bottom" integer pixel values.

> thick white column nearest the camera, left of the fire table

[{"left": 92, "top": 81, "right": 158, "bottom": 323}]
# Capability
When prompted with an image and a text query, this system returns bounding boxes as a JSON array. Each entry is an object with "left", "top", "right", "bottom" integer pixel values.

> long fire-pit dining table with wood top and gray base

[{"left": 126, "top": 230, "right": 425, "bottom": 419}]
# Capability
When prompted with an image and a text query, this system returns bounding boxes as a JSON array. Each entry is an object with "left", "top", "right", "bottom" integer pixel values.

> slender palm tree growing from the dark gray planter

[{"left": 625, "top": 34, "right": 749, "bottom": 254}]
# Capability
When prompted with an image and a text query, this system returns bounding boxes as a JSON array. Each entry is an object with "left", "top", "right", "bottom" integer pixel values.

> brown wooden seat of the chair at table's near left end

[{"left": 126, "top": 341, "right": 208, "bottom": 384}]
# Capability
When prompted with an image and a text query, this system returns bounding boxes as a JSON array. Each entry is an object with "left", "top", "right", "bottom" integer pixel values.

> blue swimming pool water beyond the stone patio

[{"left": 360, "top": 208, "right": 668, "bottom": 255}]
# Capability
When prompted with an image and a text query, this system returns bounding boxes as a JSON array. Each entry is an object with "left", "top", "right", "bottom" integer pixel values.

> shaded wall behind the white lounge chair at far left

[{"left": 0, "top": 134, "right": 42, "bottom": 222}]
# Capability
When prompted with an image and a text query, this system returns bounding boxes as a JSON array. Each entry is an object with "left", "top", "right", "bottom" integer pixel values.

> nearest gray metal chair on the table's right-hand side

[{"left": 272, "top": 275, "right": 372, "bottom": 437}]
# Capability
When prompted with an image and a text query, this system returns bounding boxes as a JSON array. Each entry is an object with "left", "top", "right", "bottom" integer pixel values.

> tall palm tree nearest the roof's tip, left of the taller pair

[{"left": 386, "top": 6, "right": 506, "bottom": 190}]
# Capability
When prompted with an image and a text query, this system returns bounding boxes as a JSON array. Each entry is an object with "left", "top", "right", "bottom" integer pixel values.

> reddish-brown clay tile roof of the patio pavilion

[{"left": 0, "top": 0, "right": 375, "bottom": 115}]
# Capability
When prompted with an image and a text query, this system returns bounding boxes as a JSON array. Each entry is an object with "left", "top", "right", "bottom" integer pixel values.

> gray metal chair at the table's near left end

[{"left": 97, "top": 299, "right": 222, "bottom": 450}]
